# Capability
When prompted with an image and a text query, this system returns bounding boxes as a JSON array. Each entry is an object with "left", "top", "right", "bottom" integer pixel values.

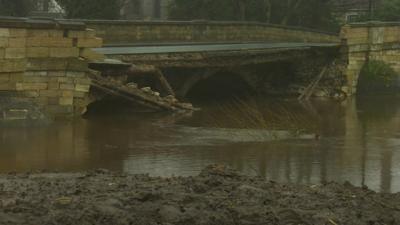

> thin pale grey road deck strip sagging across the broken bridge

[{"left": 95, "top": 43, "right": 340, "bottom": 55}]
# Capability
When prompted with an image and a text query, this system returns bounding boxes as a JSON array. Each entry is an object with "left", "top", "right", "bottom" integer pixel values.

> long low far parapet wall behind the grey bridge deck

[{"left": 82, "top": 20, "right": 340, "bottom": 45}]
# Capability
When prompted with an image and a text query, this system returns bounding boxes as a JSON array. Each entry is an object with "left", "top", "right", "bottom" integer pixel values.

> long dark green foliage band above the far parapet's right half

[{"left": 170, "top": 0, "right": 339, "bottom": 31}]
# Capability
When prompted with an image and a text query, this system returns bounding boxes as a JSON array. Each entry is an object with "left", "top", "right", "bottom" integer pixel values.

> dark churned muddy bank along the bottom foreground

[{"left": 0, "top": 166, "right": 400, "bottom": 225}]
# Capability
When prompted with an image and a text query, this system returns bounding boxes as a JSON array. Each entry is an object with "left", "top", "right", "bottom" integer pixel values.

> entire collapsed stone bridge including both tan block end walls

[{"left": 0, "top": 18, "right": 400, "bottom": 118}]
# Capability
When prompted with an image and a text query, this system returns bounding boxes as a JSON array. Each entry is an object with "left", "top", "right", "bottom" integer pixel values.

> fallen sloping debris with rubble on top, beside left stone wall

[{"left": 90, "top": 62, "right": 196, "bottom": 112}]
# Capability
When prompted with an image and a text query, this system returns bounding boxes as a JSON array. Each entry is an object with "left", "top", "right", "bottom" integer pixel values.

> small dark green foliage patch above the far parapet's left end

[{"left": 57, "top": 0, "right": 121, "bottom": 20}]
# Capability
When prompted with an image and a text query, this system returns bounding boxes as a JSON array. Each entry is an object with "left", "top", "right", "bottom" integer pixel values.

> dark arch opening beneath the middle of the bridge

[{"left": 184, "top": 71, "right": 256, "bottom": 102}]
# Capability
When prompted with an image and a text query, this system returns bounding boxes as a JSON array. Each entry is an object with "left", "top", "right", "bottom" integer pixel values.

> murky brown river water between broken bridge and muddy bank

[{"left": 0, "top": 97, "right": 400, "bottom": 192}]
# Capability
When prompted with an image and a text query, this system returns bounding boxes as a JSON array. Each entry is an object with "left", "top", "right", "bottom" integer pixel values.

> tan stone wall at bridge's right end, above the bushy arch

[{"left": 341, "top": 22, "right": 400, "bottom": 95}]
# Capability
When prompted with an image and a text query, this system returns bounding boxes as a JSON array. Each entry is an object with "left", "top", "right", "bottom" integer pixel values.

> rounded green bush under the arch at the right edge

[{"left": 359, "top": 60, "right": 398, "bottom": 90}]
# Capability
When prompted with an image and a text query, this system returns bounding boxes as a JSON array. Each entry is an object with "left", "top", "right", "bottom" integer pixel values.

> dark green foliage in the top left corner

[{"left": 0, "top": 0, "right": 34, "bottom": 17}]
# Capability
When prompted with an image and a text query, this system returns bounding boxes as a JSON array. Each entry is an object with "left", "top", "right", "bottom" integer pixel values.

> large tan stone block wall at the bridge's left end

[{"left": 0, "top": 19, "right": 102, "bottom": 118}]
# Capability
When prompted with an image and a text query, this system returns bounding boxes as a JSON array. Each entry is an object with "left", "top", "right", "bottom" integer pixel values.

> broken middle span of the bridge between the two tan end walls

[{"left": 83, "top": 21, "right": 340, "bottom": 99}]
